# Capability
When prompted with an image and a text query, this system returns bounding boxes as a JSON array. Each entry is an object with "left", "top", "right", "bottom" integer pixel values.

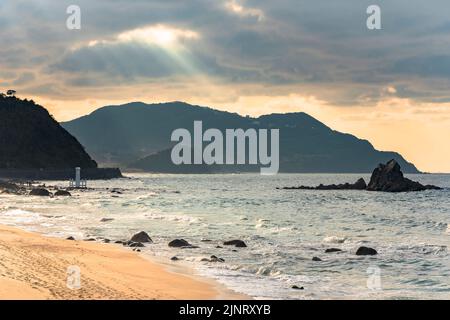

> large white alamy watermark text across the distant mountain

[{"left": 171, "top": 121, "right": 280, "bottom": 175}]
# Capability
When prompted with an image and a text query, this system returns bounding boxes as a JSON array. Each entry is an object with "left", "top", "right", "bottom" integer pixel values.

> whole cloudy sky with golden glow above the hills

[{"left": 0, "top": 0, "right": 450, "bottom": 172}]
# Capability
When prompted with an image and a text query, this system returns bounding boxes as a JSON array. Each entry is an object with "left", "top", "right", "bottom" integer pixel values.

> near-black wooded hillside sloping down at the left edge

[{"left": 0, "top": 95, "right": 97, "bottom": 169}]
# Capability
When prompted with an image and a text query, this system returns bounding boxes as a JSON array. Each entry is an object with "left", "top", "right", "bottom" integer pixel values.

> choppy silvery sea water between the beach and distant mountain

[{"left": 0, "top": 174, "right": 450, "bottom": 299}]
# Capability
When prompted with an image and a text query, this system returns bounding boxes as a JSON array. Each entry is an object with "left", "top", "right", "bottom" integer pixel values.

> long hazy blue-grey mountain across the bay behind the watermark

[{"left": 62, "top": 102, "right": 418, "bottom": 173}]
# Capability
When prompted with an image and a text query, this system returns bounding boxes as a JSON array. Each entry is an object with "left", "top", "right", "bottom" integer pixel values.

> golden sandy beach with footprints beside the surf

[{"left": 0, "top": 226, "right": 238, "bottom": 300}]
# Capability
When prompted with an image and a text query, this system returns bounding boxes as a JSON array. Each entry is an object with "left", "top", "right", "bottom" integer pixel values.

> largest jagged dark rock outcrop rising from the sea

[{"left": 367, "top": 160, "right": 440, "bottom": 192}]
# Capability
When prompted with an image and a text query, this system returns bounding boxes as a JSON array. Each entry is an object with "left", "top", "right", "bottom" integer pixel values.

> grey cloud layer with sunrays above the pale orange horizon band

[{"left": 0, "top": 0, "right": 450, "bottom": 106}]
